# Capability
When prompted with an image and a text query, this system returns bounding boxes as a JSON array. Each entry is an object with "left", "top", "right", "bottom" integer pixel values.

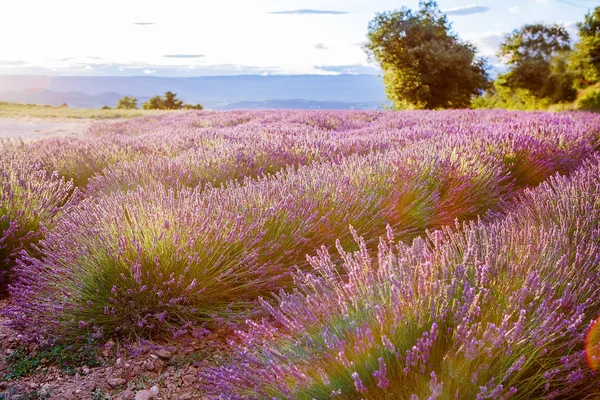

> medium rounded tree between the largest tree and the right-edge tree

[{"left": 498, "top": 24, "right": 570, "bottom": 98}]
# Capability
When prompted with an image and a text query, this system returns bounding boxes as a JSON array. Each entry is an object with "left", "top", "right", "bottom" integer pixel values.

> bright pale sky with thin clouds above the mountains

[{"left": 0, "top": 0, "right": 600, "bottom": 77}]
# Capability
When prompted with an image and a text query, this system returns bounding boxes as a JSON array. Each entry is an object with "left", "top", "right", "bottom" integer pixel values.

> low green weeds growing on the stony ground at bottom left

[{"left": 2, "top": 341, "right": 100, "bottom": 380}]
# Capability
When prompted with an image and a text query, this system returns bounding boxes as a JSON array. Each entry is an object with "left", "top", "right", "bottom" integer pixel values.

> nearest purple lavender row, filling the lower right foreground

[{"left": 199, "top": 158, "right": 600, "bottom": 400}]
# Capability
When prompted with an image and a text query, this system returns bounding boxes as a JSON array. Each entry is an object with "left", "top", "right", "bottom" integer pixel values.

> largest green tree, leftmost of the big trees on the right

[{"left": 365, "top": 0, "right": 488, "bottom": 109}]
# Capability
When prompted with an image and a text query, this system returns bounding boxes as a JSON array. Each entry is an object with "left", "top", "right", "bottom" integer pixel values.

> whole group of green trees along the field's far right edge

[{"left": 364, "top": 0, "right": 600, "bottom": 109}]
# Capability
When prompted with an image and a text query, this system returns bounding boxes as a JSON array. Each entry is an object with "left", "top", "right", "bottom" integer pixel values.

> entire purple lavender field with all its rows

[{"left": 0, "top": 110, "right": 600, "bottom": 400}]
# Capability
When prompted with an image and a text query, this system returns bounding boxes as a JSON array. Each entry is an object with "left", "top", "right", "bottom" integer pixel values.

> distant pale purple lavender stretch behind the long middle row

[{"left": 24, "top": 111, "right": 598, "bottom": 195}]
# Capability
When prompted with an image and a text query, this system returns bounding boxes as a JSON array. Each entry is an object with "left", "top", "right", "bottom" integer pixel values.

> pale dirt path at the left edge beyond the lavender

[{"left": 0, "top": 118, "right": 91, "bottom": 140}]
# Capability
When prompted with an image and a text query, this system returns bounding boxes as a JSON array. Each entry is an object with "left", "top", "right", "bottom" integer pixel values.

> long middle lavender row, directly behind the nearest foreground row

[{"left": 7, "top": 114, "right": 597, "bottom": 339}]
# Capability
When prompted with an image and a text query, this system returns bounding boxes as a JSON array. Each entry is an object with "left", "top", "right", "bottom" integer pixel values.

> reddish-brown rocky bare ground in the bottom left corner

[{"left": 0, "top": 300, "right": 226, "bottom": 400}]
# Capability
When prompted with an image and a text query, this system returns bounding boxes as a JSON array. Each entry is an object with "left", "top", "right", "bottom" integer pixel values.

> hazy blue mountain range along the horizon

[{"left": 0, "top": 75, "right": 385, "bottom": 110}]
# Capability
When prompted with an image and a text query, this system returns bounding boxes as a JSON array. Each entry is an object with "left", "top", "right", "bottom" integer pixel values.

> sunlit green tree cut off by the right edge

[{"left": 569, "top": 6, "right": 600, "bottom": 88}]
